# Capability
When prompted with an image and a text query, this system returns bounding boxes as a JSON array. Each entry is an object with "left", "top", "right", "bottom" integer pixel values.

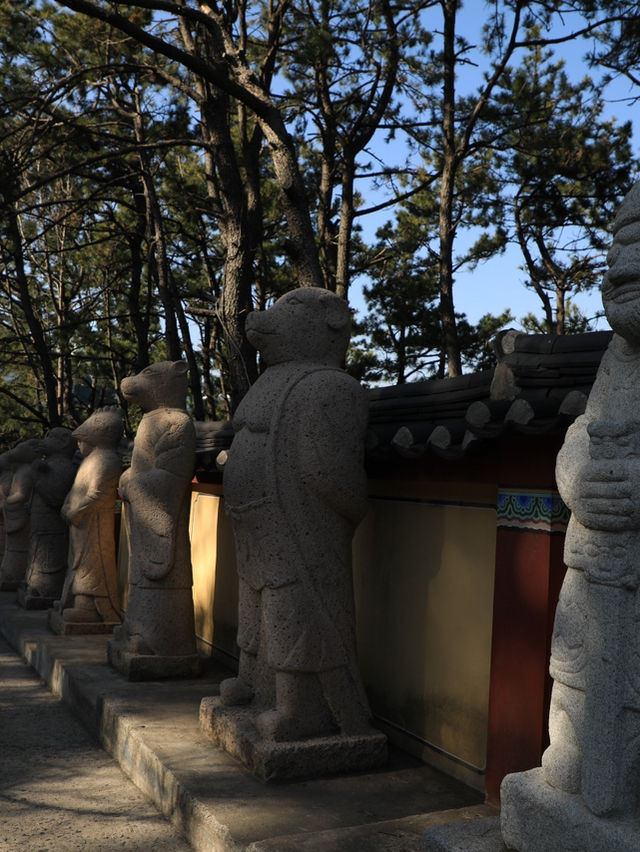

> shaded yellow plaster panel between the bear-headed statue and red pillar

[{"left": 354, "top": 484, "right": 496, "bottom": 788}]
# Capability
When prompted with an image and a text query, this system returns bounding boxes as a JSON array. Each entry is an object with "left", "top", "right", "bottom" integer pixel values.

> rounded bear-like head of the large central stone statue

[{"left": 246, "top": 287, "right": 351, "bottom": 367}]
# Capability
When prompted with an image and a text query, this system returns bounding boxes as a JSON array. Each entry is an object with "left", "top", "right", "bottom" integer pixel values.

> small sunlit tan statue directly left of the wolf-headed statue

[{"left": 50, "top": 406, "right": 123, "bottom": 633}]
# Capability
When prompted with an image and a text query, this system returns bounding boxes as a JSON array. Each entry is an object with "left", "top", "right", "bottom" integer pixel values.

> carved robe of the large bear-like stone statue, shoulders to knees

[{"left": 224, "top": 363, "right": 367, "bottom": 683}]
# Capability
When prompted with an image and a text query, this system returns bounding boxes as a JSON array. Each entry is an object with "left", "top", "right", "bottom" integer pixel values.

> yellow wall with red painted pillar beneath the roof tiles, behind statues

[{"left": 112, "top": 440, "right": 564, "bottom": 802}]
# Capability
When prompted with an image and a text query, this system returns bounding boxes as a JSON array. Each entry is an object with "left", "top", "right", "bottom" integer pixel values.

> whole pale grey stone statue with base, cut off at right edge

[{"left": 502, "top": 184, "right": 640, "bottom": 852}]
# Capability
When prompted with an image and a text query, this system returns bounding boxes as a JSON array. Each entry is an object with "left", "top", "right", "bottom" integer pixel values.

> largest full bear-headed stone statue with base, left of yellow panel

[{"left": 201, "top": 288, "right": 385, "bottom": 777}]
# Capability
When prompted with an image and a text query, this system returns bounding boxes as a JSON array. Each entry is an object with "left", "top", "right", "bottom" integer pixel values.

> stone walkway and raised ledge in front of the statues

[{"left": 0, "top": 593, "right": 496, "bottom": 852}]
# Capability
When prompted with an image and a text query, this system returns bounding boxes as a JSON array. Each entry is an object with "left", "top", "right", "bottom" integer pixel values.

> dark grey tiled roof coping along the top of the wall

[{"left": 196, "top": 330, "right": 612, "bottom": 470}]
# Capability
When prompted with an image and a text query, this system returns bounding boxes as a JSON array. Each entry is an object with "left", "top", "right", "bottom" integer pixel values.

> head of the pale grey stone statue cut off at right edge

[{"left": 602, "top": 183, "right": 640, "bottom": 344}]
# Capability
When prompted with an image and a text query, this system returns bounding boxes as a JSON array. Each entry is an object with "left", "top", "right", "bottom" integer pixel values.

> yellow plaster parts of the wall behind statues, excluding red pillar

[{"left": 119, "top": 484, "right": 496, "bottom": 789}]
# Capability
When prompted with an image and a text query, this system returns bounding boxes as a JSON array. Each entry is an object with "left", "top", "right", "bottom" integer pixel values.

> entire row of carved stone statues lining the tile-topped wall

[{"left": 0, "top": 184, "right": 640, "bottom": 804}]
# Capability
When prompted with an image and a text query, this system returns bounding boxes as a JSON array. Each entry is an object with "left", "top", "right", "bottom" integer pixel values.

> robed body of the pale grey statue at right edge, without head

[{"left": 543, "top": 335, "right": 640, "bottom": 814}]
